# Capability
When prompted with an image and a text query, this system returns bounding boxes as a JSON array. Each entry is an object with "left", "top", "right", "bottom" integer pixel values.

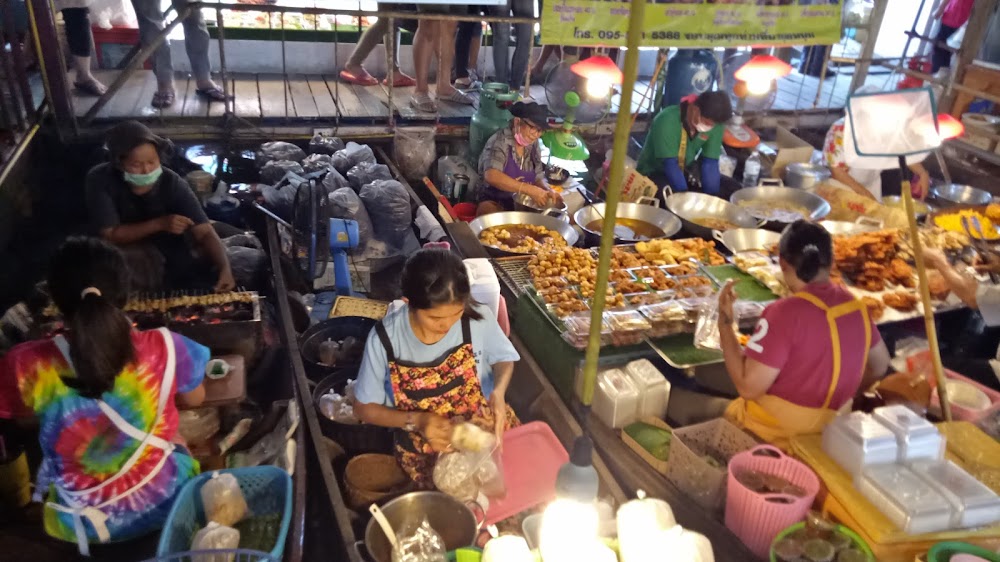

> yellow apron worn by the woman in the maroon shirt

[{"left": 725, "top": 292, "right": 872, "bottom": 450}]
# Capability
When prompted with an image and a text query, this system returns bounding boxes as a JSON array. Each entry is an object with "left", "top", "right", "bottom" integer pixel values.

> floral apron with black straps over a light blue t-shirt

[{"left": 375, "top": 316, "right": 520, "bottom": 489}]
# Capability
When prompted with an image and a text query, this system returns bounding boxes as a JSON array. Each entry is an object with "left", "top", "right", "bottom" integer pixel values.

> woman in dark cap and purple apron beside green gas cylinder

[{"left": 476, "top": 102, "right": 562, "bottom": 215}]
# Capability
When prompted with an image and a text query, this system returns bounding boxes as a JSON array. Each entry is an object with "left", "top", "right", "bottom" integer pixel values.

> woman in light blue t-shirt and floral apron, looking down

[{"left": 354, "top": 249, "right": 520, "bottom": 488}]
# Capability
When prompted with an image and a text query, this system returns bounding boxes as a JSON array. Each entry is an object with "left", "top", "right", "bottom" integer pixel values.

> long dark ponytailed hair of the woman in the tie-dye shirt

[{"left": 48, "top": 237, "right": 135, "bottom": 398}]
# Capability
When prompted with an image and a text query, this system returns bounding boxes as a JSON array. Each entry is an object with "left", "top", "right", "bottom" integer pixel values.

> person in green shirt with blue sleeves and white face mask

[{"left": 636, "top": 91, "right": 733, "bottom": 195}]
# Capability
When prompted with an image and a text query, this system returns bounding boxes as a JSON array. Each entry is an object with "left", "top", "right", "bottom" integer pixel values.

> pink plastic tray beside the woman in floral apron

[{"left": 486, "top": 422, "right": 569, "bottom": 525}]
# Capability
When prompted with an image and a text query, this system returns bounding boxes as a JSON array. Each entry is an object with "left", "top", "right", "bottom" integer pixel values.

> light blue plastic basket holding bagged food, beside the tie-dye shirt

[{"left": 156, "top": 466, "right": 292, "bottom": 562}]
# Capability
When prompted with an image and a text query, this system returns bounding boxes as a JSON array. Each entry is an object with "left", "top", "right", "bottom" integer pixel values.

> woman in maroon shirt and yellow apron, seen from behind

[{"left": 719, "top": 221, "right": 889, "bottom": 448}]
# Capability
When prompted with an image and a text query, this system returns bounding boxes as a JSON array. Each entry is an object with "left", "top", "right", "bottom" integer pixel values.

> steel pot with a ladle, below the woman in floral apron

[{"left": 365, "top": 492, "right": 485, "bottom": 562}]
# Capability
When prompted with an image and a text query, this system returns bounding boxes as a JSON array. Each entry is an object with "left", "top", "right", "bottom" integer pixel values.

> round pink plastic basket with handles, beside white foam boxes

[{"left": 726, "top": 445, "right": 819, "bottom": 559}]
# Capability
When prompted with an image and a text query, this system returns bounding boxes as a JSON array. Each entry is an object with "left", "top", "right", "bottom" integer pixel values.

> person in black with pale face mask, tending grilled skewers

[{"left": 86, "top": 121, "right": 236, "bottom": 292}]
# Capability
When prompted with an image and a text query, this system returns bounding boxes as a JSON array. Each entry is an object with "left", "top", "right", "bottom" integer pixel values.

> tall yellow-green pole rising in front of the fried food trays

[{"left": 583, "top": 0, "right": 646, "bottom": 406}]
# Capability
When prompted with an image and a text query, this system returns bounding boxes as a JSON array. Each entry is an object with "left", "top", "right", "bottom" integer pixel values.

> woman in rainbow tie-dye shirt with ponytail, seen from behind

[{"left": 0, "top": 238, "right": 209, "bottom": 554}]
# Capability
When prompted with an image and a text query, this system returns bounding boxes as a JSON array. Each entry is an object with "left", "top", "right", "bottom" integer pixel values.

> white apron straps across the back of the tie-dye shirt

[{"left": 47, "top": 328, "right": 177, "bottom": 556}]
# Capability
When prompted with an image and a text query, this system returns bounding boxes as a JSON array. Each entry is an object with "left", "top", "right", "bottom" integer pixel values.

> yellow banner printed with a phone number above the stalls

[{"left": 542, "top": 0, "right": 841, "bottom": 47}]
